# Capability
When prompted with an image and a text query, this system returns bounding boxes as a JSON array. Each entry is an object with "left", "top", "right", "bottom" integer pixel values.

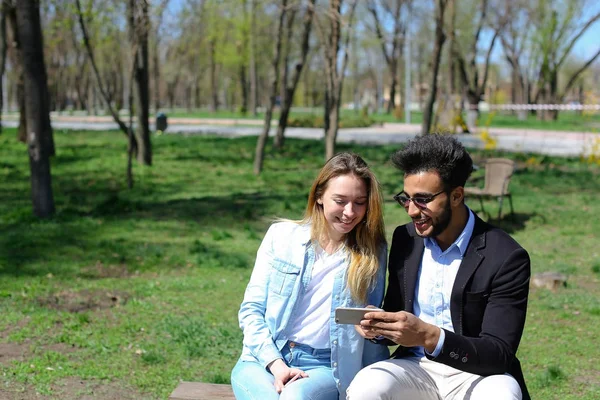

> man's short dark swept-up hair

[{"left": 392, "top": 133, "right": 473, "bottom": 190}]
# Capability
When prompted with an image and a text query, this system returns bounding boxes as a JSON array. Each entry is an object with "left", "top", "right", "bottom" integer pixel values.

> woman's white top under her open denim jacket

[{"left": 288, "top": 245, "right": 347, "bottom": 349}]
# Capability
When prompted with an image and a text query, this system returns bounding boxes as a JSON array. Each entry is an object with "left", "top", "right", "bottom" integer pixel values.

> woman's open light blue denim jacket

[{"left": 238, "top": 222, "right": 389, "bottom": 398}]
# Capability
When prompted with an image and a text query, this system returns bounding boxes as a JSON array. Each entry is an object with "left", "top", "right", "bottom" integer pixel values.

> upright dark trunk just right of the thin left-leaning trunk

[{"left": 128, "top": 0, "right": 152, "bottom": 165}]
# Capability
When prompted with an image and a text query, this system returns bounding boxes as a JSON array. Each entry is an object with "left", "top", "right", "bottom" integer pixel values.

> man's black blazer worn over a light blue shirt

[{"left": 383, "top": 216, "right": 530, "bottom": 400}]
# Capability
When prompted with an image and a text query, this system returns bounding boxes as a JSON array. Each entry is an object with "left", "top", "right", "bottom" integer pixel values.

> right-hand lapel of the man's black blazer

[{"left": 450, "top": 216, "right": 485, "bottom": 335}]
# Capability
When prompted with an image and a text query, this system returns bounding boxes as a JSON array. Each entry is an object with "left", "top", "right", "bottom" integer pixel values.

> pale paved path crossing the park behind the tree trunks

[{"left": 3, "top": 116, "right": 600, "bottom": 156}]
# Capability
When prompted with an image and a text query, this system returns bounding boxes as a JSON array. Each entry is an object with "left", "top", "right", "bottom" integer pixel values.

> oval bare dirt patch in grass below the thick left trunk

[{"left": 38, "top": 290, "right": 130, "bottom": 313}]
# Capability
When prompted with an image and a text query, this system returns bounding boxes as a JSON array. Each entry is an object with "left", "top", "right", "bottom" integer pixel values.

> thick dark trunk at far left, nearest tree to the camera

[{"left": 16, "top": 0, "right": 54, "bottom": 218}]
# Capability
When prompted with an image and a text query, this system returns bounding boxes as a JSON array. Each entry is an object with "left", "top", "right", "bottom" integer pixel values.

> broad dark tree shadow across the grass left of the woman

[{"left": 0, "top": 191, "right": 305, "bottom": 279}]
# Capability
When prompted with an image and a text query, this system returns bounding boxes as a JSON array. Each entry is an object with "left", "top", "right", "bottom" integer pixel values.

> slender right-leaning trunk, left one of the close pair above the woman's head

[{"left": 254, "top": 0, "right": 287, "bottom": 175}]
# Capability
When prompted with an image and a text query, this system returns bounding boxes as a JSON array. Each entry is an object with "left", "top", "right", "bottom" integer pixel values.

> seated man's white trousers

[{"left": 346, "top": 357, "right": 522, "bottom": 400}]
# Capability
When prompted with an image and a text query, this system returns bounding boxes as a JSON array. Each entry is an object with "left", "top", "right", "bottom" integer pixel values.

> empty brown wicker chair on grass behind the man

[{"left": 465, "top": 158, "right": 515, "bottom": 219}]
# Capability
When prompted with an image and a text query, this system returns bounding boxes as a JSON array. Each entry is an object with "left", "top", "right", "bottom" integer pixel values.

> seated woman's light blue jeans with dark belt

[{"left": 231, "top": 342, "right": 339, "bottom": 400}]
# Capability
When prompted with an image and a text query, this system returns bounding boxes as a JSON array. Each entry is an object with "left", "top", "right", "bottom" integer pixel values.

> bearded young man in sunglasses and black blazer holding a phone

[{"left": 347, "top": 134, "right": 530, "bottom": 400}]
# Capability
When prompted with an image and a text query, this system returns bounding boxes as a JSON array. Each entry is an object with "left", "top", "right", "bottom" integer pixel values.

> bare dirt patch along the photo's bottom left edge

[{"left": 0, "top": 377, "right": 148, "bottom": 400}]
